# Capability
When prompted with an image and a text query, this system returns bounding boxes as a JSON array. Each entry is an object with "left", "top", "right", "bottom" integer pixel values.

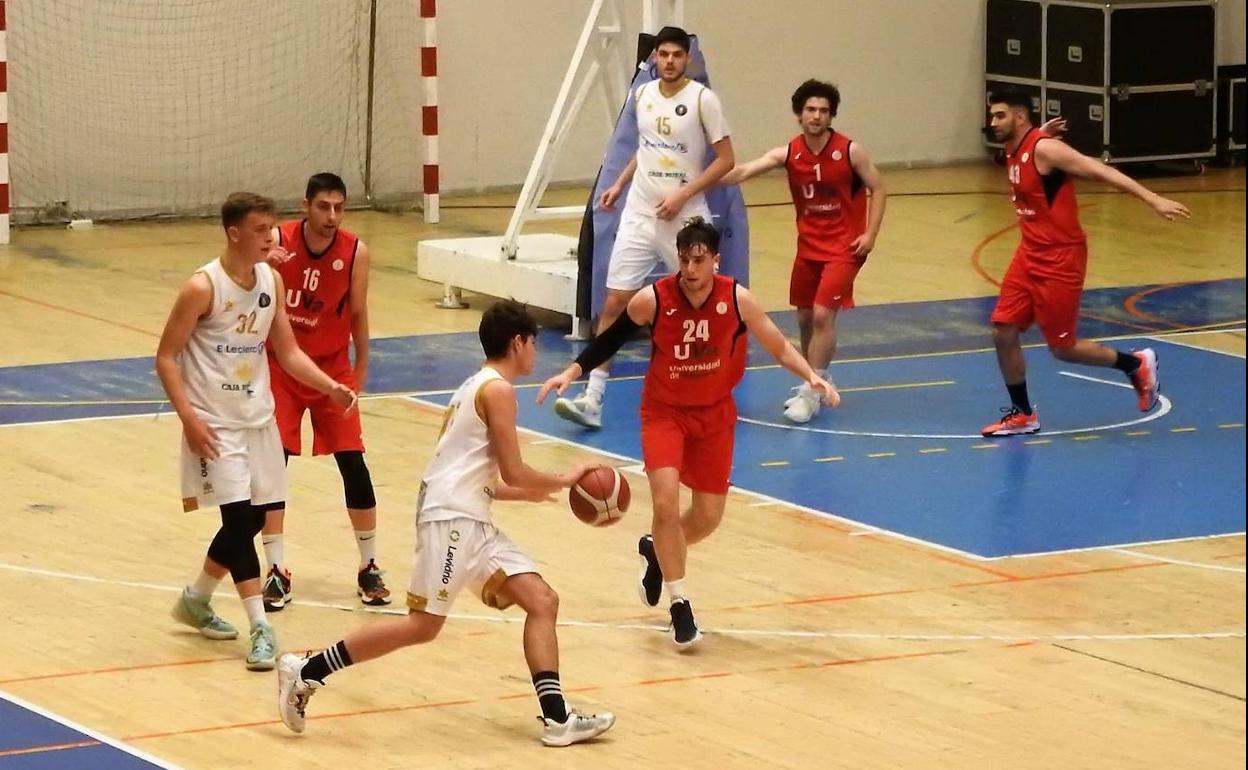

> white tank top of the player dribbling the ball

[{"left": 416, "top": 367, "right": 503, "bottom": 523}]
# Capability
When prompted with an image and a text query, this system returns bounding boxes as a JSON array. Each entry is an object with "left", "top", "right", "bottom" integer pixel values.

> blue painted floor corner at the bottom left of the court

[{"left": 0, "top": 693, "right": 176, "bottom": 770}]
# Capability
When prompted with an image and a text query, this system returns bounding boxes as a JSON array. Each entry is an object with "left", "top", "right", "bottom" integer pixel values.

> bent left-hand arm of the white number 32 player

[{"left": 156, "top": 273, "right": 217, "bottom": 459}]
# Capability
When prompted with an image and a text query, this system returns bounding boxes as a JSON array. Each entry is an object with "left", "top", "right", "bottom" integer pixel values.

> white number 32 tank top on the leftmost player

[{"left": 177, "top": 260, "right": 277, "bottom": 428}]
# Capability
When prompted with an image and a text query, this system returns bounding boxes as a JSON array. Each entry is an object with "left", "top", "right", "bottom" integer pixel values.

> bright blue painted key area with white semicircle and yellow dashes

[{"left": 414, "top": 339, "right": 1244, "bottom": 559}]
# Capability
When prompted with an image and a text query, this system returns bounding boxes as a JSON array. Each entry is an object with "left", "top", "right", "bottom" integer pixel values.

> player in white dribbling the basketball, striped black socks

[{"left": 277, "top": 301, "right": 615, "bottom": 746}]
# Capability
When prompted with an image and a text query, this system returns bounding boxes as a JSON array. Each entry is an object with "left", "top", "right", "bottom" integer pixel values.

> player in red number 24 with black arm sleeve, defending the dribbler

[{"left": 538, "top": 217, "right": 840, "bottom": 649}]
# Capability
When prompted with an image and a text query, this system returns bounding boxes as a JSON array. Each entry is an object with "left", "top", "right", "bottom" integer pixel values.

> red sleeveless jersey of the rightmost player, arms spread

[{"left": 1006, "top": 129, "right": 1087, "bottom": 252}]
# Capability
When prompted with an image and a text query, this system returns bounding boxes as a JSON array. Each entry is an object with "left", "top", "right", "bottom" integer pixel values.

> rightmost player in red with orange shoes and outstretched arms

[{"left": 982, "top": 94, "right": 1191, "bottom": 436}]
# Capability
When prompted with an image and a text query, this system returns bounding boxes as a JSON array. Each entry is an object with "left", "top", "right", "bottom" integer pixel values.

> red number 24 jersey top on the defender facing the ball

[{"left": 641, "top": 275, "right": 745, "bottom": 407}]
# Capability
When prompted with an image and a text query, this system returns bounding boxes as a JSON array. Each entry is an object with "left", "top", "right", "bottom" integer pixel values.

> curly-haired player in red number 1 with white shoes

[{"left": 719, "top": 80, "right": 887, "bottom": 423}]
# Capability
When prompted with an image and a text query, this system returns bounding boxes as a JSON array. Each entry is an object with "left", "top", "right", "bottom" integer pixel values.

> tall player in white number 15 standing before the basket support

[{"left": 554, "top": 26, "right": 735, "bottom": 428}]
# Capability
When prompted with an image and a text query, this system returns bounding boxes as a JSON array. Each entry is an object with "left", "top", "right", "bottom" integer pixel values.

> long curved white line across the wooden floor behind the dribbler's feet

[{"left": 0, "top": 563, "right": 1246, "bottom": 643}]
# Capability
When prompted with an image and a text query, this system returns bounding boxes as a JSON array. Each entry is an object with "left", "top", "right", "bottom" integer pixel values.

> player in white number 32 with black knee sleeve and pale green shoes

[{"left": 156, "top": 192, "right": 356, "bottom": 671}]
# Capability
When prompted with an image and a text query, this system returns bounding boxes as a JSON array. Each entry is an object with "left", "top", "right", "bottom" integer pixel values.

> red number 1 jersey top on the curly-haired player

[{"left": 784, "top": 131, "right": 866, "bottom": 262}]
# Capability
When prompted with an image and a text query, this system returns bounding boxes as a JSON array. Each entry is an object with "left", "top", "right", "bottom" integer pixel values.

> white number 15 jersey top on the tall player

[{"left": 625, "top": 80, "right": 728, "bottom": 217}]
